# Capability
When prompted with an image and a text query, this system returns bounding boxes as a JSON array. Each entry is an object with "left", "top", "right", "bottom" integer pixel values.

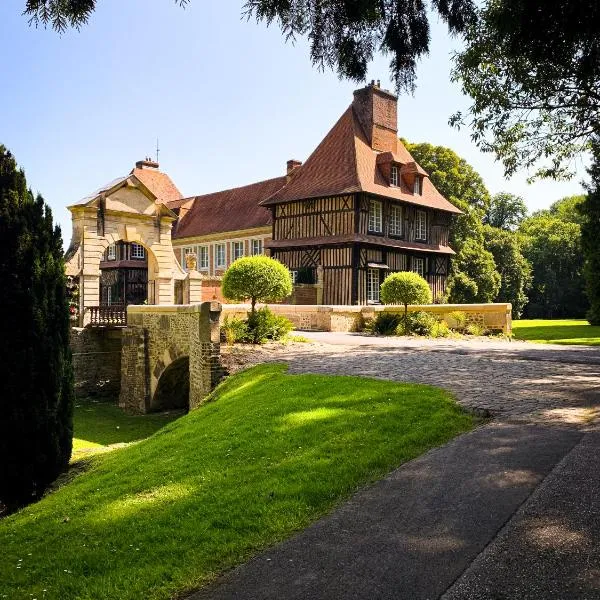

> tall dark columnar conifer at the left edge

[{"left": 0, "top": 145, "right": 74, "bottom": 508}]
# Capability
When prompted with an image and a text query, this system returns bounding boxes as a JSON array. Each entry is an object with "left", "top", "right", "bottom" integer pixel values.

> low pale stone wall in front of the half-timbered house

[{"left": 221, "top": 303, "right": 512, "bottom": 335}]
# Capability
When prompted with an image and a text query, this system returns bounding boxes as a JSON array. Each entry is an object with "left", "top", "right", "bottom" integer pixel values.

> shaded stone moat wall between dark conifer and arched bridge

[{"left": 70, "top": 327, "right": 123, "bottom": 399}]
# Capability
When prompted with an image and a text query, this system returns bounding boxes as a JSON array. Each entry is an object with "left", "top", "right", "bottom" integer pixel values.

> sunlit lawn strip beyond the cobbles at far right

[{"left": 513, "top": 319, "right": 600, "bottom": 346}]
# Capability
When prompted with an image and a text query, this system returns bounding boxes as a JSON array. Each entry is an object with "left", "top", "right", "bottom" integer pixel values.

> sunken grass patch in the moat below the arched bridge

[{"left": 73, "top": 399, "right": 182, "bottom": 460}]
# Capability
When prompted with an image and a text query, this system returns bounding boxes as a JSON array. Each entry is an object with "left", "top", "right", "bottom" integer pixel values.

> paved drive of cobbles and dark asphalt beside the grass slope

[{"left": 193, "top": 334, "right": 600, "bottom": 600}]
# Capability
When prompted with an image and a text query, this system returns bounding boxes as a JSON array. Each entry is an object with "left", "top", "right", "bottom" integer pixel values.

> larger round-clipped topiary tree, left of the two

[{"left": 221, "top": 256, "right": 292, "bottom": 312}]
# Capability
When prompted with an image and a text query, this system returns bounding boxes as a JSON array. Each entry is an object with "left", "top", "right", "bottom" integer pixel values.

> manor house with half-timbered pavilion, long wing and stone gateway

[{"left": 66, "top": 82, "right": 460, "bottom": 324}]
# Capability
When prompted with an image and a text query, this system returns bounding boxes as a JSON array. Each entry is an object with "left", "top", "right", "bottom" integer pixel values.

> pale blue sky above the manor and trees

[{"left": 0, "top": 0, "right": 585, "bottom": 243}]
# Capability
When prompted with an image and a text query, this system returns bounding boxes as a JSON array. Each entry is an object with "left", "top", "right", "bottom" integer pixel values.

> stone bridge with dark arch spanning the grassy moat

[{"left": 119, "top": 302, "right": 222, "bottom": 414}]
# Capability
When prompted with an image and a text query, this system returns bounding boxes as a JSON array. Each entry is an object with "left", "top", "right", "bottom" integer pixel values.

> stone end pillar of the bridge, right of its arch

[{"left": 190, "top": 302, "right": 222, "bottom": 410}]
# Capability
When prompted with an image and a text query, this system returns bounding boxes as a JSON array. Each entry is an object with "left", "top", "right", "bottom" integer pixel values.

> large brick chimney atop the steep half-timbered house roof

[{"left": 352, "top": 80, "right": 398, "bottom": 152}]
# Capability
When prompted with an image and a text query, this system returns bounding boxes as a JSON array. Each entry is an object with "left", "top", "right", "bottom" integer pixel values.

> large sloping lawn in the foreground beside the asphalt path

[{"left": 0, "top": 365, "right": 473, "bottom": 600}]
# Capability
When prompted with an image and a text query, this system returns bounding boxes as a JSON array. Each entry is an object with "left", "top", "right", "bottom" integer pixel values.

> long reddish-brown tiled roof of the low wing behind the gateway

[{"left": 173, "top": 176, "right": 286, "bottom": 239}]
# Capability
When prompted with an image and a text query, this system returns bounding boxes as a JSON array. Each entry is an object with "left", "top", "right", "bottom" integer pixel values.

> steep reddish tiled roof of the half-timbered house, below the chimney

[{"left": 262, "top": 105, "right": 461, "bottom": 214}]
